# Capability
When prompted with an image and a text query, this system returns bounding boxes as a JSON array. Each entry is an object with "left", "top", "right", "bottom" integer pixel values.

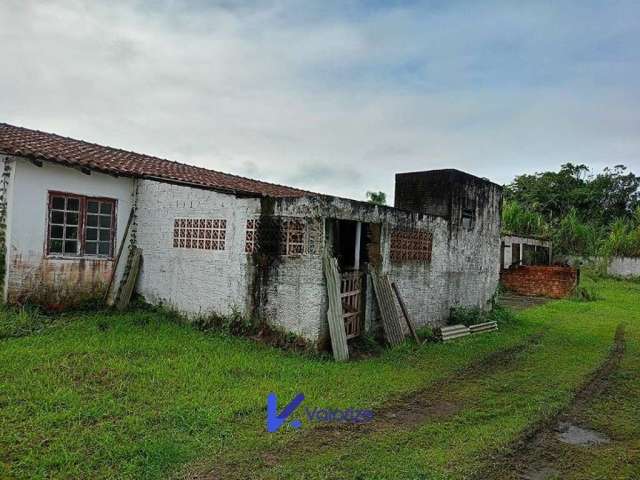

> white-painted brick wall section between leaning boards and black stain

[{"left": 136, "top": 180, "right": 260, "bottom": 316}]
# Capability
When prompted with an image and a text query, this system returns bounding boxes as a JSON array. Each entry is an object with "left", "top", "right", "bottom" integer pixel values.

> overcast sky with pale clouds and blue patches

[{"left": 0, "top": 0, "right": 640, "bottom": 199}]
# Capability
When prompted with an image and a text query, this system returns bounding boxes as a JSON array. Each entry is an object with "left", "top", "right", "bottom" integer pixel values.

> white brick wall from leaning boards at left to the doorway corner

[{"left": 136, "top": 180, "right": 326, "bottom": 342}]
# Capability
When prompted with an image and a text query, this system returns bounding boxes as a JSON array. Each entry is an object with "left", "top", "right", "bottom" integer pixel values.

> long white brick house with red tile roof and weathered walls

[{"left": 0, "top": 124, "right": 501, "bottom": 342}]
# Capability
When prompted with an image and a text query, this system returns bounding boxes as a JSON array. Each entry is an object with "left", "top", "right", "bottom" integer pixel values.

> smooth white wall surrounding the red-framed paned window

[{"left": 7, "top": 157, "right": 134, "bottom": 297}]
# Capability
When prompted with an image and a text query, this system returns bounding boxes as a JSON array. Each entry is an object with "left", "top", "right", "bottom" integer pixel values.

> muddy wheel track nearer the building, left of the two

[{"left": 188, "top": 334, "right": 542, "bottom": 480}]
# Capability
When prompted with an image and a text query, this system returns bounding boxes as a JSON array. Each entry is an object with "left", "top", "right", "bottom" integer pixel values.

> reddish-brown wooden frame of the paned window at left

[{"left": 45, "top": 190, "right": 118, "bottom": 260}]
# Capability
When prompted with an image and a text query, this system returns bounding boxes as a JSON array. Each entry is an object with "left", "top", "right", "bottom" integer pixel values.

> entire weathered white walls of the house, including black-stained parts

[{"left": 9, "top": 158, "right": 501, "bottom": 342}]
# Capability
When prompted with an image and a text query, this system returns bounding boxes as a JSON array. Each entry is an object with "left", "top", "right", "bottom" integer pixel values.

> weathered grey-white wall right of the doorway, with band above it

[{"left": 277, "top": 193, "right": 500, "bottom": 338}]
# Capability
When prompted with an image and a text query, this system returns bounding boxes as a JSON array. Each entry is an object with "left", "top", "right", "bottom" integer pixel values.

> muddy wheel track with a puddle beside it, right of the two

[{"left": 474, "top": 325, "right": 625, "bottom": 480}]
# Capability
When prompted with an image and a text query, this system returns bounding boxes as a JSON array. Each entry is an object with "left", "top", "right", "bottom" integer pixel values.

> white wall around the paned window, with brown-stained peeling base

[{"left": 6, "top": 158, "right": 133, "bottom": 309}]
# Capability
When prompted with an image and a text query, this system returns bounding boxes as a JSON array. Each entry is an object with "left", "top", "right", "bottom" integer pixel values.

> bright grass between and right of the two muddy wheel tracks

[{"left": 231, "top": 279, "right": 640, "bottom": 479}]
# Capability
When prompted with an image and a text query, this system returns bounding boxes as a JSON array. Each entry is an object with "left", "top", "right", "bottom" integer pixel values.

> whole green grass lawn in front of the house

[{"left": 0, "top": 279, "right": 640, "bottom": 479}]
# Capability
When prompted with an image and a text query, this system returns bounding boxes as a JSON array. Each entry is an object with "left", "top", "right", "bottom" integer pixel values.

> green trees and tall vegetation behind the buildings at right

[{"left": 502, "top": 163, "right": 640, "bottom": 257}]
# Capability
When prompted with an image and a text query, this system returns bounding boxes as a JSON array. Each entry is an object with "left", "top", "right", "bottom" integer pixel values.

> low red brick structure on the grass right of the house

[{"left": 500, "top": 265, "right": 578, "bottom": 298}]
